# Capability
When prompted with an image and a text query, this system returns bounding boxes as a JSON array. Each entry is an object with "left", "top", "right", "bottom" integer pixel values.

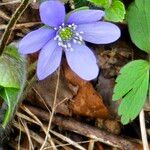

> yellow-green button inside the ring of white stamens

[{"left": 59, "top": 27, "right": 73, "bottom": 41}]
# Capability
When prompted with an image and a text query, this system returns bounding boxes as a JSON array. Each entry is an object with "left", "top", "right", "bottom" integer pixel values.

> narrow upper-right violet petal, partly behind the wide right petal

[{"left": 68, "top": 10, "right": 105, "bottom": 25}]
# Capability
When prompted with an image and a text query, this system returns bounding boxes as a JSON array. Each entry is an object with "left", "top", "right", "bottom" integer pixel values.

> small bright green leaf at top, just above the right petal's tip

[{"left": 105, "top": 0, "right": 126, "bottom": 22}]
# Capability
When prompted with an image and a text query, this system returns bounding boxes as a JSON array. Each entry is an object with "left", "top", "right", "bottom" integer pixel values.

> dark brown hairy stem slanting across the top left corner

[{"left": 0, "top": 0, "right": 30, "bottom": 55}]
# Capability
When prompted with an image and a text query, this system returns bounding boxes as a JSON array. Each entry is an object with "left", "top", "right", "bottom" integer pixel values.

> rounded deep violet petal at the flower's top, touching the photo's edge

[{"left": 40, "top": 1, "right": 66, "bottom": 27}]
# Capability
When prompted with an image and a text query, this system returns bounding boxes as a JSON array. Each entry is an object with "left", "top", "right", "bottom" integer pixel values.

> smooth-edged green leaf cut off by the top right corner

[{"left": 127, "top": 0, "right": 150, "bottom": 53}]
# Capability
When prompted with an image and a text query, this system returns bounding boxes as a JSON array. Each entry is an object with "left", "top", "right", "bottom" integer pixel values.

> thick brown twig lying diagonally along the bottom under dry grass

[{"left": 26, "top": 106, "right": 141, "bottom": 150}]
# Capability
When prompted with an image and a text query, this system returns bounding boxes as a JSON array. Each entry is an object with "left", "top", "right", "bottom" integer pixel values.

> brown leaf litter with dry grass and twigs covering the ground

[{"left": 0, "top": 0, "right": 149, "bottom": 150}]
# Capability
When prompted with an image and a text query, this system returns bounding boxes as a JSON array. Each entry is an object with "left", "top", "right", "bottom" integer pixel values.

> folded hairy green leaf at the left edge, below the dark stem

[{"left": 0, "top": 46, "right": 26, "bottom": 128}]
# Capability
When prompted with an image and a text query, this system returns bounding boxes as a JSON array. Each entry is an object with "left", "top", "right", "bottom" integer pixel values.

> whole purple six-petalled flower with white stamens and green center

[{"left": 19, "top": 1, "right": 120, "bottom": 80}]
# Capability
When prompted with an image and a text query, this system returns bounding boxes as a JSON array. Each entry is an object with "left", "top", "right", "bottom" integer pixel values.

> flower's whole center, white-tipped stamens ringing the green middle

[{"left": 54, "top": 23, "right": 83, "bottom": 51}]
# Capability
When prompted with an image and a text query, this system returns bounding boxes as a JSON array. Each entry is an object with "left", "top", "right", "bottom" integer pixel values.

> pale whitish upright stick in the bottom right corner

[{"left": 139, "top": 109, "right": 149, "bottom": 150}]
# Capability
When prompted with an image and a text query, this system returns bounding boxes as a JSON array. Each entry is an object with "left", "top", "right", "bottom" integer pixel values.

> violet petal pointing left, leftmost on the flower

[{"left": 19, "top": 27, "right": 56, "bottom": 54}]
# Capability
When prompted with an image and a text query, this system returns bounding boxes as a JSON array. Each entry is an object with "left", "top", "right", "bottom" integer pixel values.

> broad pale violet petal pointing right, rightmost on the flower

[{"left": 77, "top": 22, "right": 121, "bottom": 44}]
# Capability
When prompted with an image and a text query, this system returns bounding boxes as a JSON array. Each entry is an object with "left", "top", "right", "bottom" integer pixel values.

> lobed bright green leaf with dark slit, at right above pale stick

[{"left": 113, "top": 60, "right": 150, "bottom": 124}]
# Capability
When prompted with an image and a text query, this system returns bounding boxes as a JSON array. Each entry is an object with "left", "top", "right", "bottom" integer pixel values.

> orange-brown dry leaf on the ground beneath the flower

[{"left": 63, "top": 63, "right": 109, "bottom": 118}]
